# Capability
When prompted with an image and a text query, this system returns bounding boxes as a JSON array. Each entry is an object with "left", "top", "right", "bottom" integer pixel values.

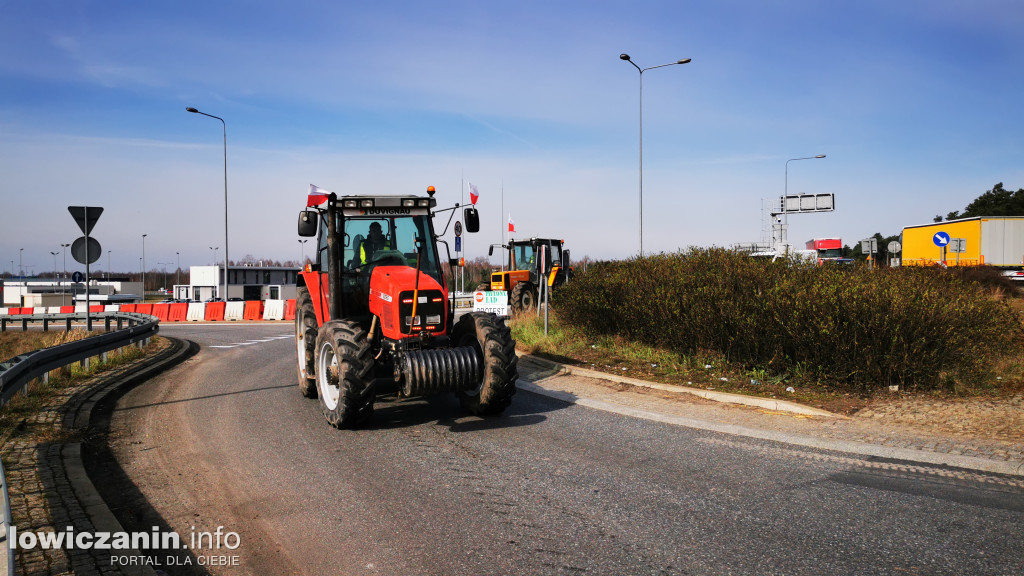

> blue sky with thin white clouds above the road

[{"left": 0, "top": 0, "right": 1024, "bottom": 273}]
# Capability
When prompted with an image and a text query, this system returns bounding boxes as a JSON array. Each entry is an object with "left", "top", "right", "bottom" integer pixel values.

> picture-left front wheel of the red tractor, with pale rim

[{"left": 316, "top": 320, "right": 376, "bottom": 428}]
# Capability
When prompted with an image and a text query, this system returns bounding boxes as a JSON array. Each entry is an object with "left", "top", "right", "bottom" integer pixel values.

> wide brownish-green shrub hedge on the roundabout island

[{"left": 552, "top": 248, "right": 1024, "bottom": 388}]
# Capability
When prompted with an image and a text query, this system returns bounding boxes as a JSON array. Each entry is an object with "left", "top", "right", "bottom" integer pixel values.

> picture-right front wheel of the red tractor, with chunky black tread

[{"left": 452, "top": 312, "right": 519, "bottom": 416}]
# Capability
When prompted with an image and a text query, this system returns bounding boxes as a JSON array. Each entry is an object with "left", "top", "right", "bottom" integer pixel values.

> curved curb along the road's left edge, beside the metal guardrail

[{"left": 60, "top": 336, "right": 199, "bottom": 576}]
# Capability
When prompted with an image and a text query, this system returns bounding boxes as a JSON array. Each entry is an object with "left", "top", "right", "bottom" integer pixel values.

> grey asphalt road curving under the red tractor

[{"left": 105, "top": 324, "right": 1024, "bottom": 576}]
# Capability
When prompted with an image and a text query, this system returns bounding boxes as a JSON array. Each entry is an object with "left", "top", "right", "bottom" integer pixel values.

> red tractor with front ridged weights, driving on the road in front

[{"left": 295, "top": 187, "right": 518, "bottom": 428}]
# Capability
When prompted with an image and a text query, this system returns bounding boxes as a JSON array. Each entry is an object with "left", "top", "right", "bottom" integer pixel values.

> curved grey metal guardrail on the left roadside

[{"left": 0, "top": 312, "right": 160, "bottom": 405}]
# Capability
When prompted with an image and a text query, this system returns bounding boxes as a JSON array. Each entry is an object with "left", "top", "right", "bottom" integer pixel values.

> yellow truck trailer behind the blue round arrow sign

[{"left": 900, "top": 216, "right": 1024, "bottom": 269}]
